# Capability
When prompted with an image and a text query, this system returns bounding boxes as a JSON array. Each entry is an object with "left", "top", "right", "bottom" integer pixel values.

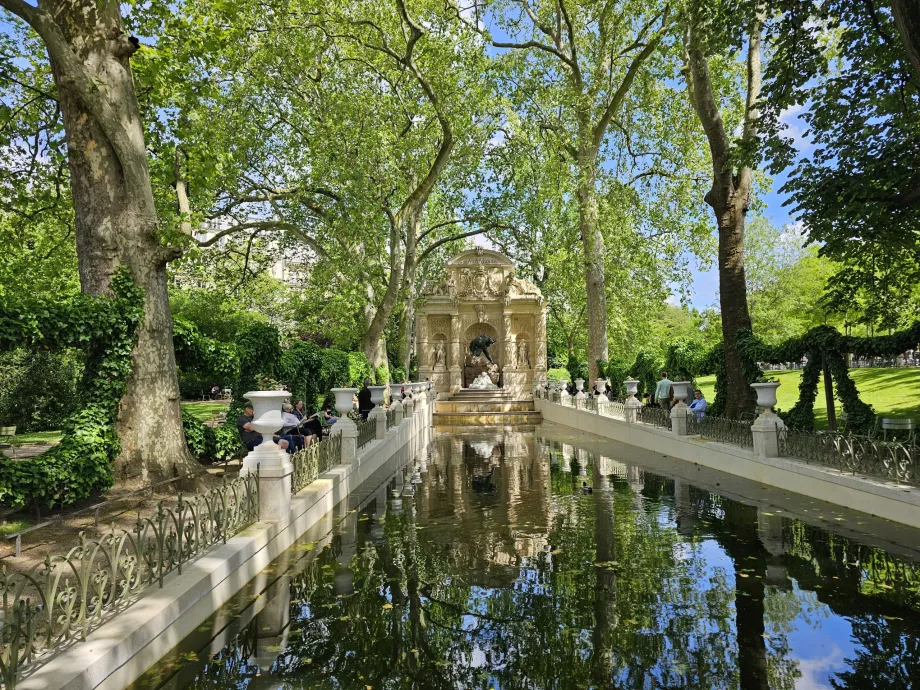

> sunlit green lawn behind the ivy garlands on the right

[{"left": 696, "top": 368, "right": 920, "bottom": 428}]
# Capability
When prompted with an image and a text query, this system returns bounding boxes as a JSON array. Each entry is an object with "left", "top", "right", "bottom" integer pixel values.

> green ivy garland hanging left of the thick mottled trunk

[{"left": 0, "top": 269, "right": 143, "bottom": 507}]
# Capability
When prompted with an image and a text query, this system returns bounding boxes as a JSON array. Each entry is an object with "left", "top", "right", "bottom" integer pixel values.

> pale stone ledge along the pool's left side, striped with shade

[{"left": 16, "top": 419, "right": 424, "bottom": 690}]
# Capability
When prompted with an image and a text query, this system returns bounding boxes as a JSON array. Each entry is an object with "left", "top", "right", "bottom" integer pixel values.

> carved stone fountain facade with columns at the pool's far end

[{"left": 416, "top": 247, "right": 546, "bottom": 400}]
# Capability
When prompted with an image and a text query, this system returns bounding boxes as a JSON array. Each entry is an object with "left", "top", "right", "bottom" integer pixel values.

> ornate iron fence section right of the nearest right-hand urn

[{"left": 779, "top": 429, "right": 920, "bottom": 486}]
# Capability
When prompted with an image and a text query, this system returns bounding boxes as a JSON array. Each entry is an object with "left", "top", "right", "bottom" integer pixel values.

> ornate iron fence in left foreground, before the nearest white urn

[{"left": 0, "top": 473, "right": 259, "bottom": 689}]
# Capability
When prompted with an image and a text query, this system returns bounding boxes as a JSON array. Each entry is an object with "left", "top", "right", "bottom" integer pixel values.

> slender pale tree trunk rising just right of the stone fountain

[{"left": 578, "top": 146, "right": 608, "bottom": 381}]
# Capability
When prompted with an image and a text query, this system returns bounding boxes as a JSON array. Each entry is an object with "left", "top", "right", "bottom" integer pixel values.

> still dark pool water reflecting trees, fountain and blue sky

[{"left": 132, "top": 425, "right": 920, "bottom": 690}]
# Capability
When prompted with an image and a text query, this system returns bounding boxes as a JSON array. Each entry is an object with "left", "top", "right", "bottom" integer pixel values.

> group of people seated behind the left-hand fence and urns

[{"left": 236, "top": 379, "right": 388, "bottom": 454}]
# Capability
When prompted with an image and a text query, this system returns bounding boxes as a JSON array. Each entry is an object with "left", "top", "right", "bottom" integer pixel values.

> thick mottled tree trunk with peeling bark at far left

[{"left": 27, "top": 0, "right": 200, "bottom": 483}]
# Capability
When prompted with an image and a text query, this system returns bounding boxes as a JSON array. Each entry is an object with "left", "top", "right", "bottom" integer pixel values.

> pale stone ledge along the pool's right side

[{"left": 536, "top": 399, "right": 920, "bottom": 527}]
